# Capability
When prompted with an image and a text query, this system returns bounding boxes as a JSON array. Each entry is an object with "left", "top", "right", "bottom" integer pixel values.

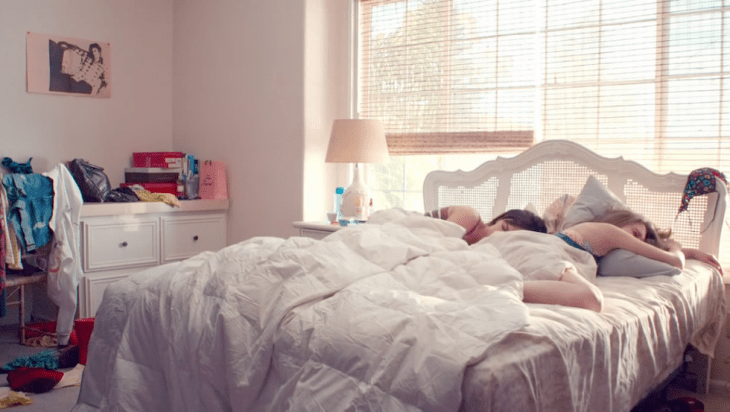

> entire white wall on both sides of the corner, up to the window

[{"left": 0, "top": 0, "right": 351, "bottom": 243}]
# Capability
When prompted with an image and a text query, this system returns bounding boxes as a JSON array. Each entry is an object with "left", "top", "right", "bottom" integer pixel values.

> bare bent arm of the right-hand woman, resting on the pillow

[{"left": 570, "top": 222, "right": 685, "bottom": 269}]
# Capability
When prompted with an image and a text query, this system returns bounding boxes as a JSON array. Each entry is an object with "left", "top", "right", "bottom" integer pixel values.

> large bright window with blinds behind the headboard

[{"left": 357, "top": 0, "right": 730, "bottom": 262}]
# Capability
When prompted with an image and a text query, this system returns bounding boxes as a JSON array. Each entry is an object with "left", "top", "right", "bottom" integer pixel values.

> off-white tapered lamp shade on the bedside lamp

[{"left": 325, "top": 119, "right": 388, "bottom": 163}]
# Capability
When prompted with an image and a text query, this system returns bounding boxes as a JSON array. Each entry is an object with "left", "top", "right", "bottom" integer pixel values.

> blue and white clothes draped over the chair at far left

[{"left": 0, "top": 157, "right": 83, "bottom": 346}]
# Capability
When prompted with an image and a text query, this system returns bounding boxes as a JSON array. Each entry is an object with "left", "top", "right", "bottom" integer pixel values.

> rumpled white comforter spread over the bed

[{"left": 73, "top": 210, "right": 528, "bottom": 412}]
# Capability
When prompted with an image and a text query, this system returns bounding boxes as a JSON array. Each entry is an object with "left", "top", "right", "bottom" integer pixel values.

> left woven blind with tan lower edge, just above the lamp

[{"left": 358, "top": 0, "right": 535, "bottom": 155}]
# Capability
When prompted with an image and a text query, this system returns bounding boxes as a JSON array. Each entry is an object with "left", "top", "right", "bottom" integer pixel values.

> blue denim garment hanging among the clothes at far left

[{"left": 3, "top": 173, "right": 53, "bottom": 252}]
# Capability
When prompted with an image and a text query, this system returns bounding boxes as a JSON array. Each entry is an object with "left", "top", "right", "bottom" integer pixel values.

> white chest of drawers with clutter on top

[{"left": 79, "top": 200, "right": 228, "bottom": 318}]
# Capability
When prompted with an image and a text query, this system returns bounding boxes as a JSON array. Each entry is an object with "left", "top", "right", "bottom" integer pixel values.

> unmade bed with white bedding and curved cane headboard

[{"left": 73, "top": 141, "right": 727, "bottom": 412}]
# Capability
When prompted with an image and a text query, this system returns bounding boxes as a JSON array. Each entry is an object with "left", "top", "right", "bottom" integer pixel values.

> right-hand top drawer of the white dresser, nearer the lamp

[{"left": 162, "top": 214, "right": 226, "bottom": 263}]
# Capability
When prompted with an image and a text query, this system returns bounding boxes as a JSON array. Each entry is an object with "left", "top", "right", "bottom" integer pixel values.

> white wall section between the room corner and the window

[{"left": 173, "top": 0, "right": 349, "bottom": 243}]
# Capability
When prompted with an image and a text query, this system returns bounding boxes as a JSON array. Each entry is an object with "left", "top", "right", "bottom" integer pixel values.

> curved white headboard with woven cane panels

[{"left": 423, "top": 140, "right": 728, "bottom": 256}]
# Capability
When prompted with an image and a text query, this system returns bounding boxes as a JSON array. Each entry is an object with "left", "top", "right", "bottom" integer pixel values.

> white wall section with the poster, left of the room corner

[{"left": 0, "top": 0, "right": 173, "bottom": 183}]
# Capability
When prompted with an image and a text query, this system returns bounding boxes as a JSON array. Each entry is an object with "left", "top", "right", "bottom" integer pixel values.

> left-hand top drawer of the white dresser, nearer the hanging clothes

[{"left": 82, "top": 218, "right": 160, "bottom": 272}]
